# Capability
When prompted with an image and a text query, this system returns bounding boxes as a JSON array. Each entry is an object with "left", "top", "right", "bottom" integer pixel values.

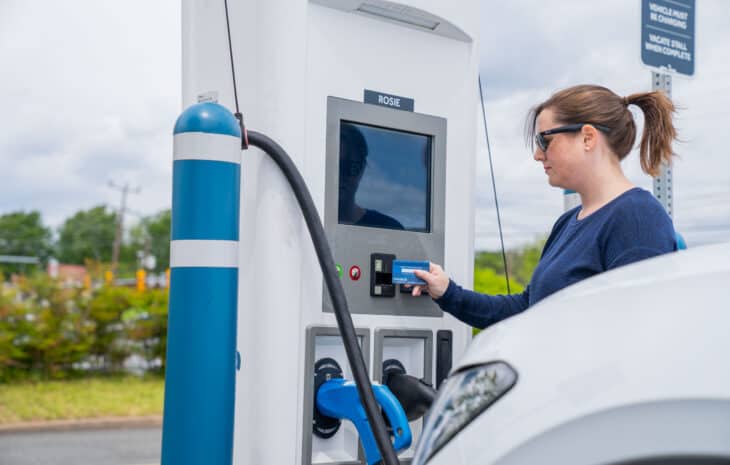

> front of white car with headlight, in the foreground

[{"left": 413, "top": 243, "right": 730, "bottom": 465}]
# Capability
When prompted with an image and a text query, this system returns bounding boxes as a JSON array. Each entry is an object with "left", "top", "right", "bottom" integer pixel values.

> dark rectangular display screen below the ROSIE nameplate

[{"left": 338, "top": 121, "right": 431, "bottom": 232}]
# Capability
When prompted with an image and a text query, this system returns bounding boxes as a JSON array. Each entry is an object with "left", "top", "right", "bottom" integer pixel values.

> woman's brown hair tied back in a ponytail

[{"left": 525, "top": 85, "right": 677, "bottom": 176}]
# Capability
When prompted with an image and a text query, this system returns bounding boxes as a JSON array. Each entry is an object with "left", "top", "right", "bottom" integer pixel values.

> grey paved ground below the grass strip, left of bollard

[{"left": 0, "top": 427, "right": 162, "bottom": 465}]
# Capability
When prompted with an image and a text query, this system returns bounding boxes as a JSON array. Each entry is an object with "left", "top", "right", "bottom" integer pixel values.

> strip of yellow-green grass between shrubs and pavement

[{"left": 0, "top": 376, "right": 164, "bottom": 424}]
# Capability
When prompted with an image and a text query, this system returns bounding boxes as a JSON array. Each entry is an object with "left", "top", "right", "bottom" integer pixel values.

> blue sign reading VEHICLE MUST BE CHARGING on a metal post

[{"left": 641, "top": 0, "right": 696, "bottom": 76}]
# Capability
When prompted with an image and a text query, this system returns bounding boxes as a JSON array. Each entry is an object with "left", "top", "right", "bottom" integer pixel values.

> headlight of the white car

[{"left": 413, "top": 362, "right": 517, "bottom": 465}]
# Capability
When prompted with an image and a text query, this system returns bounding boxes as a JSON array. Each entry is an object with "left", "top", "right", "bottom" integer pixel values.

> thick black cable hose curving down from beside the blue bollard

[{"left": 248, "top": 131, "right": 400, "bottom": 465}]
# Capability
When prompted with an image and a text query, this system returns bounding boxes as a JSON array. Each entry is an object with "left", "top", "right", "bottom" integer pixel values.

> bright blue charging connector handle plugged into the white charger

[{"left": 317, "top": 378, "right": 413, "bottom": 465}]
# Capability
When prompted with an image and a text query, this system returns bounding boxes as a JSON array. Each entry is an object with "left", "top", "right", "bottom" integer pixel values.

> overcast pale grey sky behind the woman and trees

[{"left": 0, "top": 0, "right": 730, "bottom": 249}]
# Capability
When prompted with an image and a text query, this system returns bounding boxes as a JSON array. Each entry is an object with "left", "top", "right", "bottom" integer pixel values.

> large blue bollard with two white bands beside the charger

[{"left": 162, "top": 103, "right": 241, "bottom": 465}]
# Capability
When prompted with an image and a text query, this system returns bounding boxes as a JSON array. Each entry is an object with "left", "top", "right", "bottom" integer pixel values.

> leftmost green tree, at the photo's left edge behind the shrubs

[{"left": 0, "top": 211, "right": 51, "bottom": 276}]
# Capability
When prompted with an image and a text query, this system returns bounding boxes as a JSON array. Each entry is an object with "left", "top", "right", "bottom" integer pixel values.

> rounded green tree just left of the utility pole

[{"left": 56, "top": 205, "right": 117, "bottom": 265}]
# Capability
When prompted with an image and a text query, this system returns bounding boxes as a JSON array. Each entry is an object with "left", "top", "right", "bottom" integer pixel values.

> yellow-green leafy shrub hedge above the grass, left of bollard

[{"left": 0, "top": 273, "right": 167, "bottom": 382}]
